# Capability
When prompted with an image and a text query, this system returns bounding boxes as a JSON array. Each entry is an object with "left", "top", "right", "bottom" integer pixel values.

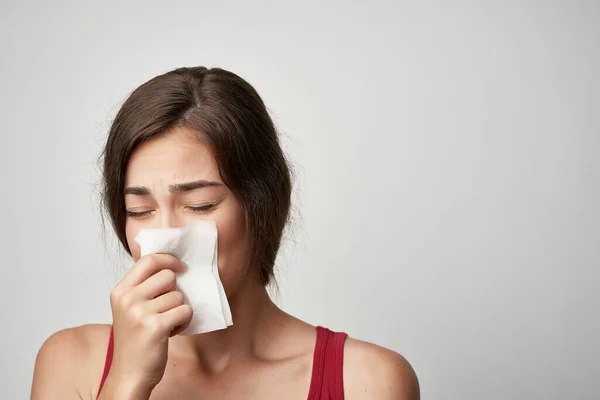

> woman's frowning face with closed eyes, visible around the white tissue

[{"left": 124, "top": 127, "right": 245, "bottom": 293}]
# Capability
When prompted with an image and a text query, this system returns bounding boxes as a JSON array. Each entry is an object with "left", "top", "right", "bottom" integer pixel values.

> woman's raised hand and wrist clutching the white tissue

[{"left": 99, "top": 254, "right": 192, "bottom": 399}]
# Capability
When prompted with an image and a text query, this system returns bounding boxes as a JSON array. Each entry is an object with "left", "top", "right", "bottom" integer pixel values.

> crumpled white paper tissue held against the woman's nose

[{"left": 135, "top": 221, "right": 233, "bottom": 335}]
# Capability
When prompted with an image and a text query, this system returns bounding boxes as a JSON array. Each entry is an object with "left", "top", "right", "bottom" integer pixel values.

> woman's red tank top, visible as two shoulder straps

[{"left": 96, "top": 326, "right": 347, "bottom": 400}]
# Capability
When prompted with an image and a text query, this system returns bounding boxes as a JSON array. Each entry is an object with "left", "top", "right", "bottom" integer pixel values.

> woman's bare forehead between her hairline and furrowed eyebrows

[{"left": 125, "top": 127, "right": 221, "bottom": 186}]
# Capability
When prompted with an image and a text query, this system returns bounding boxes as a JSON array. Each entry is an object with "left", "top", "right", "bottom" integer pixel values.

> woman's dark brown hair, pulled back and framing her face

[{"left": 102, "top": 67, "right": 292, "bottom": 285}]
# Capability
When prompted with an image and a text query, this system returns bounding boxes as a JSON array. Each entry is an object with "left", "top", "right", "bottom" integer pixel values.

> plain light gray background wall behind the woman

[{"left": 0, "top": 0, "right": 600, "bottom": 400}]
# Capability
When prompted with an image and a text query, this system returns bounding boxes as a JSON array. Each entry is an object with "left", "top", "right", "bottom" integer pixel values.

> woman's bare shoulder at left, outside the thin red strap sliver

[{"left": 31, "top": 324, "right": 110, "bottom": 400}]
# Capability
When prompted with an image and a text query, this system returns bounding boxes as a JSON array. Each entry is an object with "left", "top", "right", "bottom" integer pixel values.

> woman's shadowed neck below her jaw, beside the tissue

[{"left": 171, "top": 278, "right": 287, "bottom": 374}]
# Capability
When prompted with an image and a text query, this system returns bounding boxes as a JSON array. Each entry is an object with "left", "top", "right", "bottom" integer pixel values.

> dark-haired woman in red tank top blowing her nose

[{"left": 32, "top": 67, "right": 419, "bottom": 400}]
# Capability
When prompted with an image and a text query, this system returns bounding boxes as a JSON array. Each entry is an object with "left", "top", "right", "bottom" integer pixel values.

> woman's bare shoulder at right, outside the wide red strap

[{"left": 344, "top": 338, "right": 420, "bottom": 400}]
